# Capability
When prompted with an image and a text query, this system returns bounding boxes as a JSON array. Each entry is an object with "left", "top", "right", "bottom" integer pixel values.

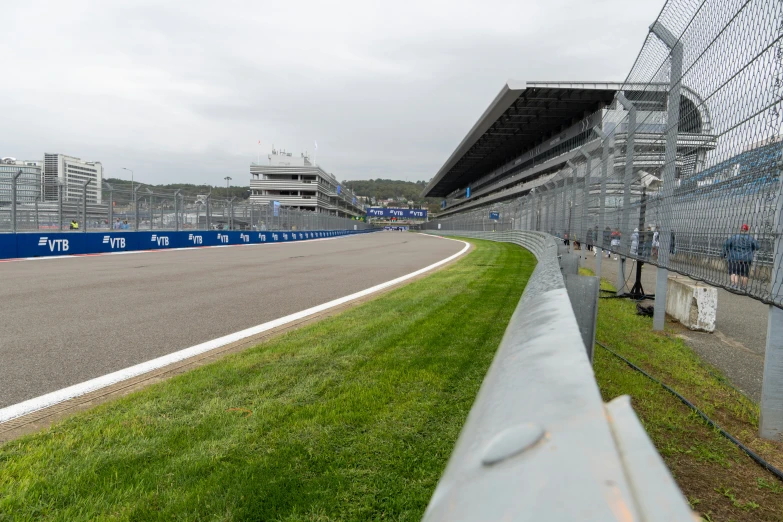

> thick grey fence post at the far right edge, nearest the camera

[{"left": 759, "top": 155, "right": 783, "bottom": 440}]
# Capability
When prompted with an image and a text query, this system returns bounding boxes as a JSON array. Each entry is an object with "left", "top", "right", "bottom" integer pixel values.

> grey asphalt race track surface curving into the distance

[{"left": 0, "top": 232, "right": 464, "bottom": 408}]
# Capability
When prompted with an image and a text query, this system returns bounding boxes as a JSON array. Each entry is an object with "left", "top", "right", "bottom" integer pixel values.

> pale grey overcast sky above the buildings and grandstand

[{"left": 0, "top": 0, "right": 663, "bottom": 185}]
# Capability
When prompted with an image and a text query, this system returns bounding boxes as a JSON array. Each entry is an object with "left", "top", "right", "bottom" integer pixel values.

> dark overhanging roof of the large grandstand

[{"left": 423, "top": 80, "right": 709, "bottom": 197}]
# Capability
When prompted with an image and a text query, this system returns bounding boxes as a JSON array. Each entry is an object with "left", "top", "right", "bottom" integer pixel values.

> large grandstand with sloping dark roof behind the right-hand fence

[{"left": 423, "top": 81, "right": 716, "bottom": 217}]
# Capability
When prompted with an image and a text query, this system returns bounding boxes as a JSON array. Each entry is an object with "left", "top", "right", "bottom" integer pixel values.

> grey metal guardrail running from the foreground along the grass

[{"left": 424, "top": 230, "right": 693, "bottom": 522}]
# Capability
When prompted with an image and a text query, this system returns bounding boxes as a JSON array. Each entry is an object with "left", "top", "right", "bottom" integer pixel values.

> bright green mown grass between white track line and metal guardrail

[{"left": 0, "top": 240, "right": 535, "bottom": 521}]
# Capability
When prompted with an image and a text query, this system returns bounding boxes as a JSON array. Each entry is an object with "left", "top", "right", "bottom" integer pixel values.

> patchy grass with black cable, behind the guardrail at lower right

[{"left": 583, "top": 269, "right": 783, "bottom": 521}]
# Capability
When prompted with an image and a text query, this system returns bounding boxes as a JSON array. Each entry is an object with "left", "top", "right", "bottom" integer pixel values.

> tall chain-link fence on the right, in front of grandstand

[{"left": 426, "top": 0, "right": 783, "bottom": 307}]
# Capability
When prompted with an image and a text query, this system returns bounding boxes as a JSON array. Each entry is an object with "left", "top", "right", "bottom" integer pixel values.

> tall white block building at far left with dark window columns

[{"left": 41, "top": 153, "right": 103, "bottom": 204}]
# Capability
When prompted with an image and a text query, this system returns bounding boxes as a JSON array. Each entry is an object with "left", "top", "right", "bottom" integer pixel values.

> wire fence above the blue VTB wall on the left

[{"left": 0, "top": 181, "right": 368, "bottom": 233}]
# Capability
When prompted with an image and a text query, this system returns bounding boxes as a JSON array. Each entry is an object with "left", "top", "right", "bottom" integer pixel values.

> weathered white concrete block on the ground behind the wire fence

[{"left": 666, "top": 277, "right": 718, "bottom": 332}]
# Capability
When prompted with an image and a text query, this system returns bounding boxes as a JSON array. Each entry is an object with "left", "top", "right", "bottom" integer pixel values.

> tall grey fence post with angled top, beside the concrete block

[{"left": 650, "top": 22, "right": 683, "bottom": 331}]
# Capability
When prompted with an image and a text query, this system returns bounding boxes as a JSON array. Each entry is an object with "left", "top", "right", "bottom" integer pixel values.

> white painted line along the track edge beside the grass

[{"left": 0, "top": 236, "right": 470, "bottom": 423}]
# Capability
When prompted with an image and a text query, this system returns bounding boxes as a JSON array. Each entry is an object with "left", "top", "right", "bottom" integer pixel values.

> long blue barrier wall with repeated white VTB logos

[{"left": 0, "top": 229, "right": 376, "bottom": 259}]
